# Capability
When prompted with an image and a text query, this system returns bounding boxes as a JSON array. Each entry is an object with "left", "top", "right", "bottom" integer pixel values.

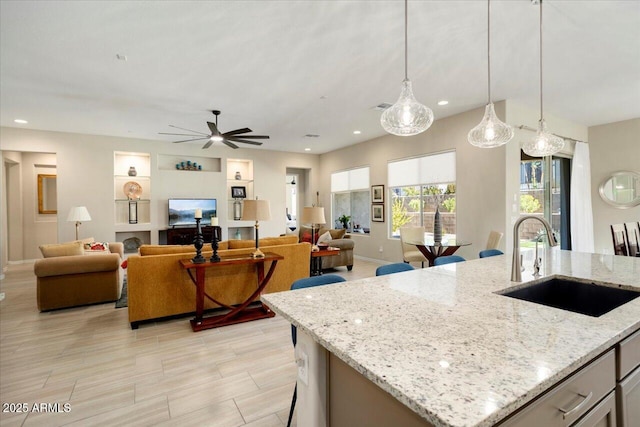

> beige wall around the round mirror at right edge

[{"left": 589, "top": 118, "right": 640, "bottom": 253}]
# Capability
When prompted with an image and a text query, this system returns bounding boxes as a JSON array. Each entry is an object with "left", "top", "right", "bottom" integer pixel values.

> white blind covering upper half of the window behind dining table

[{"left": 387, "top": 151, "right": 456, "bottom": 187}]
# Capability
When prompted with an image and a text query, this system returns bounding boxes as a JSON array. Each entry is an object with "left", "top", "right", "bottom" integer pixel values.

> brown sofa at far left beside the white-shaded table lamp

[{"left": 33, "top": 241, "right": 123, "bottom": 311}]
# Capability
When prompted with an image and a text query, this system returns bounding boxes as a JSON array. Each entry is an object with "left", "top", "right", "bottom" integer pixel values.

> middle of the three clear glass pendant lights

[{"left": 467, "top": 0, "right": 514, "bottom": 148}]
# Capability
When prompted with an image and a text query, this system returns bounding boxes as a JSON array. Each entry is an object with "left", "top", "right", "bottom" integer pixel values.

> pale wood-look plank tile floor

[{"left": 0, "top": 259, "right": 379, "bottom": 427}]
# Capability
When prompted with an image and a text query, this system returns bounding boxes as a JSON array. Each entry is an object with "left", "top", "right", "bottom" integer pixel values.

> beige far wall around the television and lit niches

[{"left": 0, "top": 127, "right": 319, "bottom": 259}]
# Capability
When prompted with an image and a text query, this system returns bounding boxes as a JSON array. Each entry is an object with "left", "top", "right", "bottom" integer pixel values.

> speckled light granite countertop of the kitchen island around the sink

[{"left": 262, "top": 249, "right": 640, "bottom": 427}]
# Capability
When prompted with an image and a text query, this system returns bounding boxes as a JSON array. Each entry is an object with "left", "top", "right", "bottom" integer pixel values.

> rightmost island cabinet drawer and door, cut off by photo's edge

[{"left": 616, "top": 331, "right": 640, "bottom": 427}]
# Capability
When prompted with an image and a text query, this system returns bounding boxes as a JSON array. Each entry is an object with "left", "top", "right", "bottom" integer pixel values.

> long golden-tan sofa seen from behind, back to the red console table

[{"left": 127, "top": 236, "right": 311, "bottom": 329}]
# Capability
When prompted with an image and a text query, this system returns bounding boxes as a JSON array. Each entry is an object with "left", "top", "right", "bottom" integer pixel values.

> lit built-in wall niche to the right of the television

[{"left": 227, "top": 159, "right": 254, "bottom": 239}]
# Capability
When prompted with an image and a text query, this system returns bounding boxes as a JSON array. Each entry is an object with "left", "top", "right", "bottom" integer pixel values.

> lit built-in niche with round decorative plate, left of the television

[{"left": 113, "top": 151, "right": 152, "bottom": 247}]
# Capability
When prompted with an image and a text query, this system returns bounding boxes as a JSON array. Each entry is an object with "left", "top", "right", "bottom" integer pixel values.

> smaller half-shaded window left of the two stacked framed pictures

[{"left": 331, "top": 167, "right": 371, "bottom": 233}]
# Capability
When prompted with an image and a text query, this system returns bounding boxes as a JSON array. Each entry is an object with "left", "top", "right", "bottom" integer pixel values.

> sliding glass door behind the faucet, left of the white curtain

[{"left": 520, "top": 153, "right": 571, "bottom": 249}]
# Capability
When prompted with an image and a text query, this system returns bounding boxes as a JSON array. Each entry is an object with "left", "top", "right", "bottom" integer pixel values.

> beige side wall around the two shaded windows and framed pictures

[{"left": 320, "top": 102, "right": 506, "bottom": 262}]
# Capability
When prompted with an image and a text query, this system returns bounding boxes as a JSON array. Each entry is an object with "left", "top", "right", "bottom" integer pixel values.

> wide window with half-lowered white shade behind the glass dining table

[{"left": 387, "top": 151, "right": 456, "bottom": 238}]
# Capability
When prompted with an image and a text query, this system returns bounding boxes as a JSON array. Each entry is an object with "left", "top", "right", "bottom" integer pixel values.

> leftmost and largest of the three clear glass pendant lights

[{"left": 380, "top": 0, "right": 433, "bottom": 136}]
